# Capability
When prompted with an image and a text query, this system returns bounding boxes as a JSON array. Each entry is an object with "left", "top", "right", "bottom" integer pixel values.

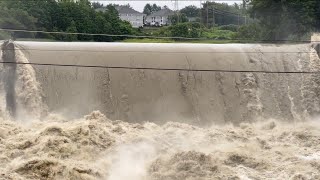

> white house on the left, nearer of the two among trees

[{"left": 116, "top": 6, "right": 145, "bottom": 28}]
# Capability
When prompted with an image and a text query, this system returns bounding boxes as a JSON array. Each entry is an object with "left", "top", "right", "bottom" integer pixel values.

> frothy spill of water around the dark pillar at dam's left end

[{"left": 2, "top": 40, "right": 47, "bottom": 121}]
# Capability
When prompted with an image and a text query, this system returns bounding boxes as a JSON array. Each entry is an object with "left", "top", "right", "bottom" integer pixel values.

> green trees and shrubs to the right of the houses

[{"left": 170, "top": 0, "right": 320, "bottom": 42}]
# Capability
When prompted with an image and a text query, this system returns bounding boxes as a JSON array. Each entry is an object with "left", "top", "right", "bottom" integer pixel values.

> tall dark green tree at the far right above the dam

[{"left": 249, "top": 0, "right": 320, "bottom": 40}]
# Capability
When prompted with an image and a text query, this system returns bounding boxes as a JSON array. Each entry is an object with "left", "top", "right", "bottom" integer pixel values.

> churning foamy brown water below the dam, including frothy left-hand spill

[{"left": 0, "top": 43, "right": 320, "bottom": 180}]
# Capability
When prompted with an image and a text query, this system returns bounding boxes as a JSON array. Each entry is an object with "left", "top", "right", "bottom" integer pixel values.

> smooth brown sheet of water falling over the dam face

[{"left": 0, "top": 42, "right": 320, "bottom": 125}]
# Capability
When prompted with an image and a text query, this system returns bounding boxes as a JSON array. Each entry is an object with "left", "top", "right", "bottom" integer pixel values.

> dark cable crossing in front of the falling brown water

[{"left": 0, "top": 61, "right": 320, "bottom": 74}]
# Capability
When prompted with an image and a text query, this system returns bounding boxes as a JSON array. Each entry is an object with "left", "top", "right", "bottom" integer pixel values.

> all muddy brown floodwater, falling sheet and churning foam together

[{"left": 0, "top": 42, "right": 320, "bottom": 180}]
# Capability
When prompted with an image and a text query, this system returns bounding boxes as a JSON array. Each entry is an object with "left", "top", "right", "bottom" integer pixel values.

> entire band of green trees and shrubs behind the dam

[{"left": 0, "top": 0, "right": 320, "bottom": 41}]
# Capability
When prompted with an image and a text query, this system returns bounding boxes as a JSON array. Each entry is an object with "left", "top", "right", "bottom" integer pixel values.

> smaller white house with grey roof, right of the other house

[{"left": 145, "top": 8, "right": 174, "bottom": 26}]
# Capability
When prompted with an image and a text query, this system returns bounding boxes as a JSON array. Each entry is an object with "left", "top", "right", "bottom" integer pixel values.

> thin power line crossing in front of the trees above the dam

[{"left": 0, "top": 28, "right": 320, "bottom": 43}]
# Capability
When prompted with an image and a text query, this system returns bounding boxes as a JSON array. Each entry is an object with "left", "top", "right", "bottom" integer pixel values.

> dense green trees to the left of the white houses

[{"left": 0, "top": 0, "right": 137, "bottom": 41}]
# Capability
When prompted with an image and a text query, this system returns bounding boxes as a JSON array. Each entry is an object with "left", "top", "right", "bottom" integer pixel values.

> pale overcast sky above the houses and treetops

[{"left": 91, "top": 0, "right": 242, "bottom": 12}]
